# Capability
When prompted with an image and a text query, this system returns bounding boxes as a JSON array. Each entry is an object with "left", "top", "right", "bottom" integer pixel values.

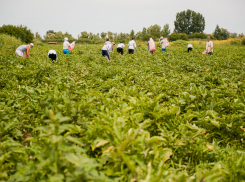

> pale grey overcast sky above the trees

[{"left": 0, "top": 0, "right": 245, "bottom": 38}]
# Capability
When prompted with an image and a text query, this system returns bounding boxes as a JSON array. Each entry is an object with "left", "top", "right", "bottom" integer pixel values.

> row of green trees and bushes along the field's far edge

[{"left": 0, "top": 9, "right": 244, "bottom": 43}]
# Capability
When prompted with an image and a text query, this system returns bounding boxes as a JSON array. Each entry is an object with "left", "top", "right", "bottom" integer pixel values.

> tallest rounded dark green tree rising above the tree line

[{"left": 174, "top": 9, "right": 205, "bottom": 35}]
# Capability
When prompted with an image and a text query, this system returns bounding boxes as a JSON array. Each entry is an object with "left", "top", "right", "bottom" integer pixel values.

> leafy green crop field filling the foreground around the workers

[{"left": 0, "top": 34, "right": 245, "bottom": 182}]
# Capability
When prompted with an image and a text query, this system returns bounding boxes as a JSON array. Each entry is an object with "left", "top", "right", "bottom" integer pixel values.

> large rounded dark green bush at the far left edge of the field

[{"left": 0, "top": 25, "right": 34, "bottom": 43}]
